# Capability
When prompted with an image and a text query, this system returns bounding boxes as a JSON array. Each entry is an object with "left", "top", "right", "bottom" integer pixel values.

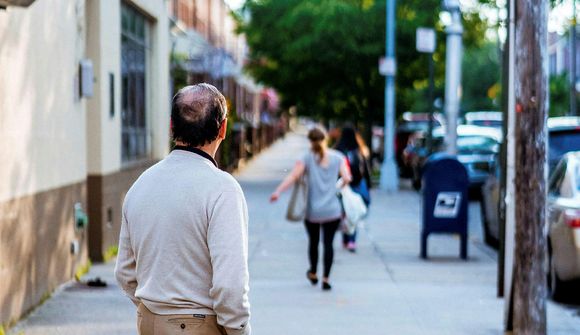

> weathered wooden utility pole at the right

[{"left": 513, "top": 0, "right": 548, "bottom": 335}]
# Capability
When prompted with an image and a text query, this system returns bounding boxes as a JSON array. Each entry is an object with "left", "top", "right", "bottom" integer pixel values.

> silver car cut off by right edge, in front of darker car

[{"left": 547, "top": 152, "right": 580, "bottom": 300}]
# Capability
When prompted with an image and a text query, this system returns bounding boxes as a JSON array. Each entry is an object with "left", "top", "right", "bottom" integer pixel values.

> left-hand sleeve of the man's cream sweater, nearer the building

[{"left": 115, "top": 213, "right": 139, "bottom": 306}]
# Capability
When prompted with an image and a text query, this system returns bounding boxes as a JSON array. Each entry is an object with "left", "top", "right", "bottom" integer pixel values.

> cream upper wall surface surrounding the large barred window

[{"left": 86, "top": 0, "right": 170, "bottom": 175}]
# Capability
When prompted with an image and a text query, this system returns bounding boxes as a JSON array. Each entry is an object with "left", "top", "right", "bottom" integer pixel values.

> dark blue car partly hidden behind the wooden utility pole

[{"left": 481, "top": 117, "right": 580, "bottom": 246}]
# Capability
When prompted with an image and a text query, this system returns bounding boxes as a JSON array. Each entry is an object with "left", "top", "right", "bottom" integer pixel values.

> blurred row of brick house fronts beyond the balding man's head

[{"left": 169, "top": 0, "right": 287, "bottom": 170}]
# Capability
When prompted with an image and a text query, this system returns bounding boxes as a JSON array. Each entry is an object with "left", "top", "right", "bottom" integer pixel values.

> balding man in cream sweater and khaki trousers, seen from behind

[{"left": 115, "top": 84, "right": 251, "bottom": 335}]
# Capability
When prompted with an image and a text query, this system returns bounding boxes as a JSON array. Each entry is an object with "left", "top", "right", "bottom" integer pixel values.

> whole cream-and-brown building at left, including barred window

[{"left": 0, "top": 0, "right": 170, "bottom": 324}]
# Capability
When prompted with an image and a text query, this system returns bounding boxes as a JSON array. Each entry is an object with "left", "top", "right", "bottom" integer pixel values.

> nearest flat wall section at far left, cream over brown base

[{"left": 0, "top": 0, "right": 87, "bottom": 324}]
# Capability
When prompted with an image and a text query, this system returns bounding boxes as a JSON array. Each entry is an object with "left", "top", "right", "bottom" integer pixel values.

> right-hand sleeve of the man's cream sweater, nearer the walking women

[{"left": 207, "top": 190, "right": 251, "bottom": 335}]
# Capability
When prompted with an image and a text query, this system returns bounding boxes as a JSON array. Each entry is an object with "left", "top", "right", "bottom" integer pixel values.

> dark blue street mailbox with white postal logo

[{"left": 421, "top": 153, "right": 469, "bottom": 259}]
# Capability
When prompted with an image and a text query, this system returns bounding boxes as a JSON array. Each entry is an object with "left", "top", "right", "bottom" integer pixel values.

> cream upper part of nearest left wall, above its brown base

[{"left": 0, "top": 0, "right": 87, "bottom": 202}]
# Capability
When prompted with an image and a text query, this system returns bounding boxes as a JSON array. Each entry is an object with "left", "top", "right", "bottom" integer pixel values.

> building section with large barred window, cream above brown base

[{"left": 84, "top": 0, "right": 171, "bottom": 261}]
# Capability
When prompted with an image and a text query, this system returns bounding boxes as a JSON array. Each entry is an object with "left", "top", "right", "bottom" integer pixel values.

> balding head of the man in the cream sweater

[{"left": 171, "top": 83, "right": 227, "bottom": 147}]
